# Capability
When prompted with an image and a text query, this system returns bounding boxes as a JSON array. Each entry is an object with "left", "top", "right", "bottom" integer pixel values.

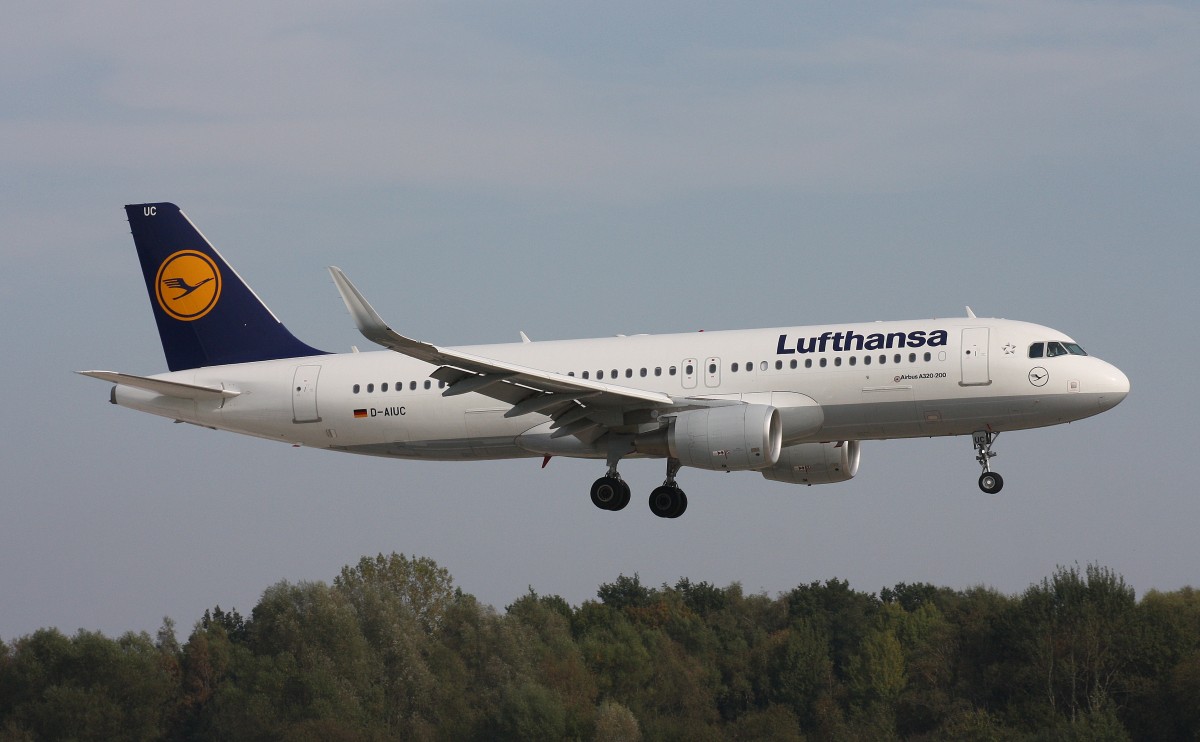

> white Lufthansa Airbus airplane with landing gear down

[{"left": 78, "top": 203, "right": 1129, "bottom": 519}]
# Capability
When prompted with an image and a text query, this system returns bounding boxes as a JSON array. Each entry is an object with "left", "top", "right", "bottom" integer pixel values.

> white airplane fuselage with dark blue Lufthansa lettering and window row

[{"left": 113, "top": 317, "right": 1129, "bottom": 460}]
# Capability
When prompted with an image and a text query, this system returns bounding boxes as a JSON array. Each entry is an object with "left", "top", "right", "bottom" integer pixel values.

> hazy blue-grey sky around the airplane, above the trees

[{"left": 0, "top": 0, "right": 1200, "bottom": 640}]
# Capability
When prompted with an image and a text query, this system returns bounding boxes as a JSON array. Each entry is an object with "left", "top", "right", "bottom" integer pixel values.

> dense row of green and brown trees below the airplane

[{"left": 0, "top": 553, "right": 1200, "bottom": 741}]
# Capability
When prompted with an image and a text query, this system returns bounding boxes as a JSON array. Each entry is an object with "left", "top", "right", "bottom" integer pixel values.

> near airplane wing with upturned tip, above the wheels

[{"left": 329, "top": 265, "right": 677, "bottom": 435}]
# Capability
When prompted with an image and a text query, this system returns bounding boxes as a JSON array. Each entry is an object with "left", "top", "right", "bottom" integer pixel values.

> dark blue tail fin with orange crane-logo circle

[{"left": 125, "top": 203, "right": 322, "bottom": 371}]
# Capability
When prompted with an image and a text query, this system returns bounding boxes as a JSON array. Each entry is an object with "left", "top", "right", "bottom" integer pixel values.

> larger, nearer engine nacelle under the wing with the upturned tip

[{"left": 667, "top": 405, "right": 784, "bottom": 472}]
